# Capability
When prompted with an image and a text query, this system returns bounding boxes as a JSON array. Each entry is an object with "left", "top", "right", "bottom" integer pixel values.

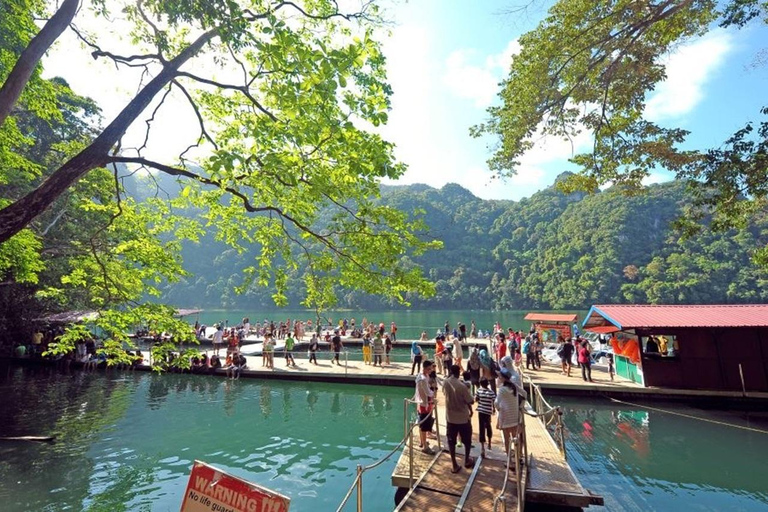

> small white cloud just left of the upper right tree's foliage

[{"left": 443, "top": 39, "right": 520, "bottom": 108}]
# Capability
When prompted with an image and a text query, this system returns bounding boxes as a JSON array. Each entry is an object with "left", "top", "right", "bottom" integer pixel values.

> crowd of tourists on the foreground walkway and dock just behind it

[{"left": 411, "top": 322, "right": 613, "bottom": 473}]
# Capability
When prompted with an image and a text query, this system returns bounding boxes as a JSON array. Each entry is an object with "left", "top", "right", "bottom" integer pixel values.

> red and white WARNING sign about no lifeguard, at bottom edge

[{"left": 181, "top": 460, "right": 291, "bottom": 512}]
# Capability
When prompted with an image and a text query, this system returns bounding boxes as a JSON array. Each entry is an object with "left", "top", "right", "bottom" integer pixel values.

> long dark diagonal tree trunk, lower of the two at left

[{"left": 0, "top": 29, "right": 218, "bottom": 244}]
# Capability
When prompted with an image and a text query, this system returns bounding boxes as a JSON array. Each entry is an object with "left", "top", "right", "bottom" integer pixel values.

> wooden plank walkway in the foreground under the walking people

[{"left": 392, "top": 406, "right": 603, "bottom": 512}]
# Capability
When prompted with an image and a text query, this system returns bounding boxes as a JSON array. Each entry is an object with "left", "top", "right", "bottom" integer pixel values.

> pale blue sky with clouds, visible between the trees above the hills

[{"left": 44, "top": 0, "right": 768, "bottom": 199}]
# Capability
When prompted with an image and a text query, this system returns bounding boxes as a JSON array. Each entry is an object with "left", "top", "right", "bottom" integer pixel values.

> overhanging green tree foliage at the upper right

[{"left": 472, "top": 0, "right": 768, "bottom": 255}]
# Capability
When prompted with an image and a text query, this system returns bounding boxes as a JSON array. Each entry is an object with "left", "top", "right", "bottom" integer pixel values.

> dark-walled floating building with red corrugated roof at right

[{"left": 583, "top": 304, "right": 768, "bottom": 391}]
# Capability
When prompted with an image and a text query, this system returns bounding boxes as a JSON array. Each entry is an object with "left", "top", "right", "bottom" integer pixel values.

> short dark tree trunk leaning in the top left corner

[{"left": 0, "top": 0, "right": 80, "bottom": 125}]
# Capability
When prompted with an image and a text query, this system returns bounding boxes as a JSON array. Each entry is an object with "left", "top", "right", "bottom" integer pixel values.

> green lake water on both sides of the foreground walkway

[{"left": 6, "top": 366, "right": 768, "bottom": 512}]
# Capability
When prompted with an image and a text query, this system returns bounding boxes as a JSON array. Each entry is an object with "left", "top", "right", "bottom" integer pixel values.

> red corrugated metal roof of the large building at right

[{"left": 584, "top": 304, "right": 768, "bottom": 329}]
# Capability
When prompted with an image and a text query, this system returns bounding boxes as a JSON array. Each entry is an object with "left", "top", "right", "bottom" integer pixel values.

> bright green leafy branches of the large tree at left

[{"left": 0, "top": 0, "right": 437, "bottom": 368}]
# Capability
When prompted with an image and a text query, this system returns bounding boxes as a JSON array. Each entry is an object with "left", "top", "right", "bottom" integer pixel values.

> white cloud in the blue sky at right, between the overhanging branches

[{"left": 645, "top": 29, "right": 733, "bottom": 121}]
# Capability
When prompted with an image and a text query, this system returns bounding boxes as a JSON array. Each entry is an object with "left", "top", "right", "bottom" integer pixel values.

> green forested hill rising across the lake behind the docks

[{"left": 156, "top": 177, "right": 768, "bottom": 309}]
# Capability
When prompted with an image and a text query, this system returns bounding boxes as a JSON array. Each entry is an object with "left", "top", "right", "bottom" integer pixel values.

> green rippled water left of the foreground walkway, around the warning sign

[{"left": 0, "top": 368, "right": 412, "bottom": 512}]
